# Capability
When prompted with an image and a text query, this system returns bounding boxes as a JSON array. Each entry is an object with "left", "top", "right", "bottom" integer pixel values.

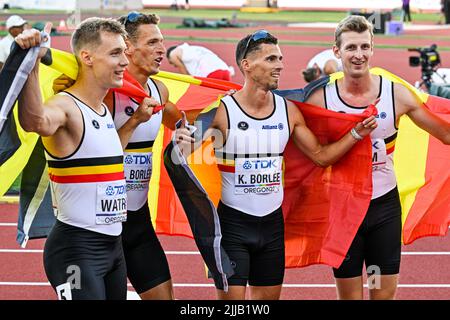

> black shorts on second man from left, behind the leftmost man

[{"left": 122, "top": 203, "right": 171, "bottom": 294}]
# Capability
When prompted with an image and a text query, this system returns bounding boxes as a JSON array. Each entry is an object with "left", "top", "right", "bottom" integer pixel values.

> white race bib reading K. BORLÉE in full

[{"left": 234, "top": 157, "right": 283, "bottom": 194}]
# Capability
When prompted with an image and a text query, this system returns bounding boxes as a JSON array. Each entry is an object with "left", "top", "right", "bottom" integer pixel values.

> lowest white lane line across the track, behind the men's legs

[{"left": 0, "top": 282, "right": 450, "bottom": 289}]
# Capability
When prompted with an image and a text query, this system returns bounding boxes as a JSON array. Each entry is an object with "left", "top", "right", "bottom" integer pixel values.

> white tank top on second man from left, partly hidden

[{"left": 113, "top": 79, "right": 163, "bottom": 211}]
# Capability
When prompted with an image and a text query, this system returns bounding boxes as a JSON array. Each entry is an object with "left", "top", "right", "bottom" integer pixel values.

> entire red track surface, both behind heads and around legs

[{"left": 0, "top": 23, "right": 450, "bottom": 300}]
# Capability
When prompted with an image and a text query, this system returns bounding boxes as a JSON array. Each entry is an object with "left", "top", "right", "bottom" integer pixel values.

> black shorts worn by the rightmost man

[{"left": 333, "top": 188, "right": 402, "bottom": 278}]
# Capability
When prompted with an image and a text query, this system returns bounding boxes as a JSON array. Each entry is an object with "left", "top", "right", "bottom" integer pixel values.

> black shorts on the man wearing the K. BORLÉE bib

[{"left": 217, "top": 202, "right": 285, "bottom": 286}]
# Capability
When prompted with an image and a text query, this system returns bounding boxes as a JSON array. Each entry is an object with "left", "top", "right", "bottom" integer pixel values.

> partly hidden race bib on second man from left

[{"left": 124, "top": 152, "right": 152, "bottom": 192}]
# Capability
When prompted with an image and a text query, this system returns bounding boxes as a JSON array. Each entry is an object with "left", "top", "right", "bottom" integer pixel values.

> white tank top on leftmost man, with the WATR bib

[{"left": 45, "top": 92, "right": 127, "bottom": 236}]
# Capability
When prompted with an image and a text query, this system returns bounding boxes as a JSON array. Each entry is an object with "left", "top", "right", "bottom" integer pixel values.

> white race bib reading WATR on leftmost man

[{"left": 95, "top": 180, "right": 127, "bottom": 224}]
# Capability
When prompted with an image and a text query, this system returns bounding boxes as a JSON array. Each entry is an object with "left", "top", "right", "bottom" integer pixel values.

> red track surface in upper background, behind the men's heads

[{"left": 52, "top": 27, "right": 450, "bottom": 89}]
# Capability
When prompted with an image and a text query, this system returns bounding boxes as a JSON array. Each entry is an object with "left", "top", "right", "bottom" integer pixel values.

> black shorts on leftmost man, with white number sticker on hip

[{"left": 44, "top": 220, "right": 127, "bottom": 300}]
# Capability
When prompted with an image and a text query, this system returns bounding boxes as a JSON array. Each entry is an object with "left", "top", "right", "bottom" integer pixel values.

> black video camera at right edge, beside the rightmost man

[{"left": 408, "top": 44, "right": 441, "bottom": 89}]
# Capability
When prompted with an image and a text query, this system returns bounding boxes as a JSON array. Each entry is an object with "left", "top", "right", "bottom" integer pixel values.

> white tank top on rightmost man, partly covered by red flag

[{"left": 325, "top": 76, "right": 397, "bottom": 199}]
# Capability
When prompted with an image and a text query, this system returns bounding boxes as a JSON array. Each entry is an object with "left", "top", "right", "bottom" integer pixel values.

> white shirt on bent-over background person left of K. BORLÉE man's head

[{"left": 180, "top": 43, "right": 228, "bottom": 77}]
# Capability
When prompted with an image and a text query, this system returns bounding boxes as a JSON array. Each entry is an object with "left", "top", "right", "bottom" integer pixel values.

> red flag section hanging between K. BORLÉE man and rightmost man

[{"left": 283, "top": 104, "right": 376, "bottom": 268}]
